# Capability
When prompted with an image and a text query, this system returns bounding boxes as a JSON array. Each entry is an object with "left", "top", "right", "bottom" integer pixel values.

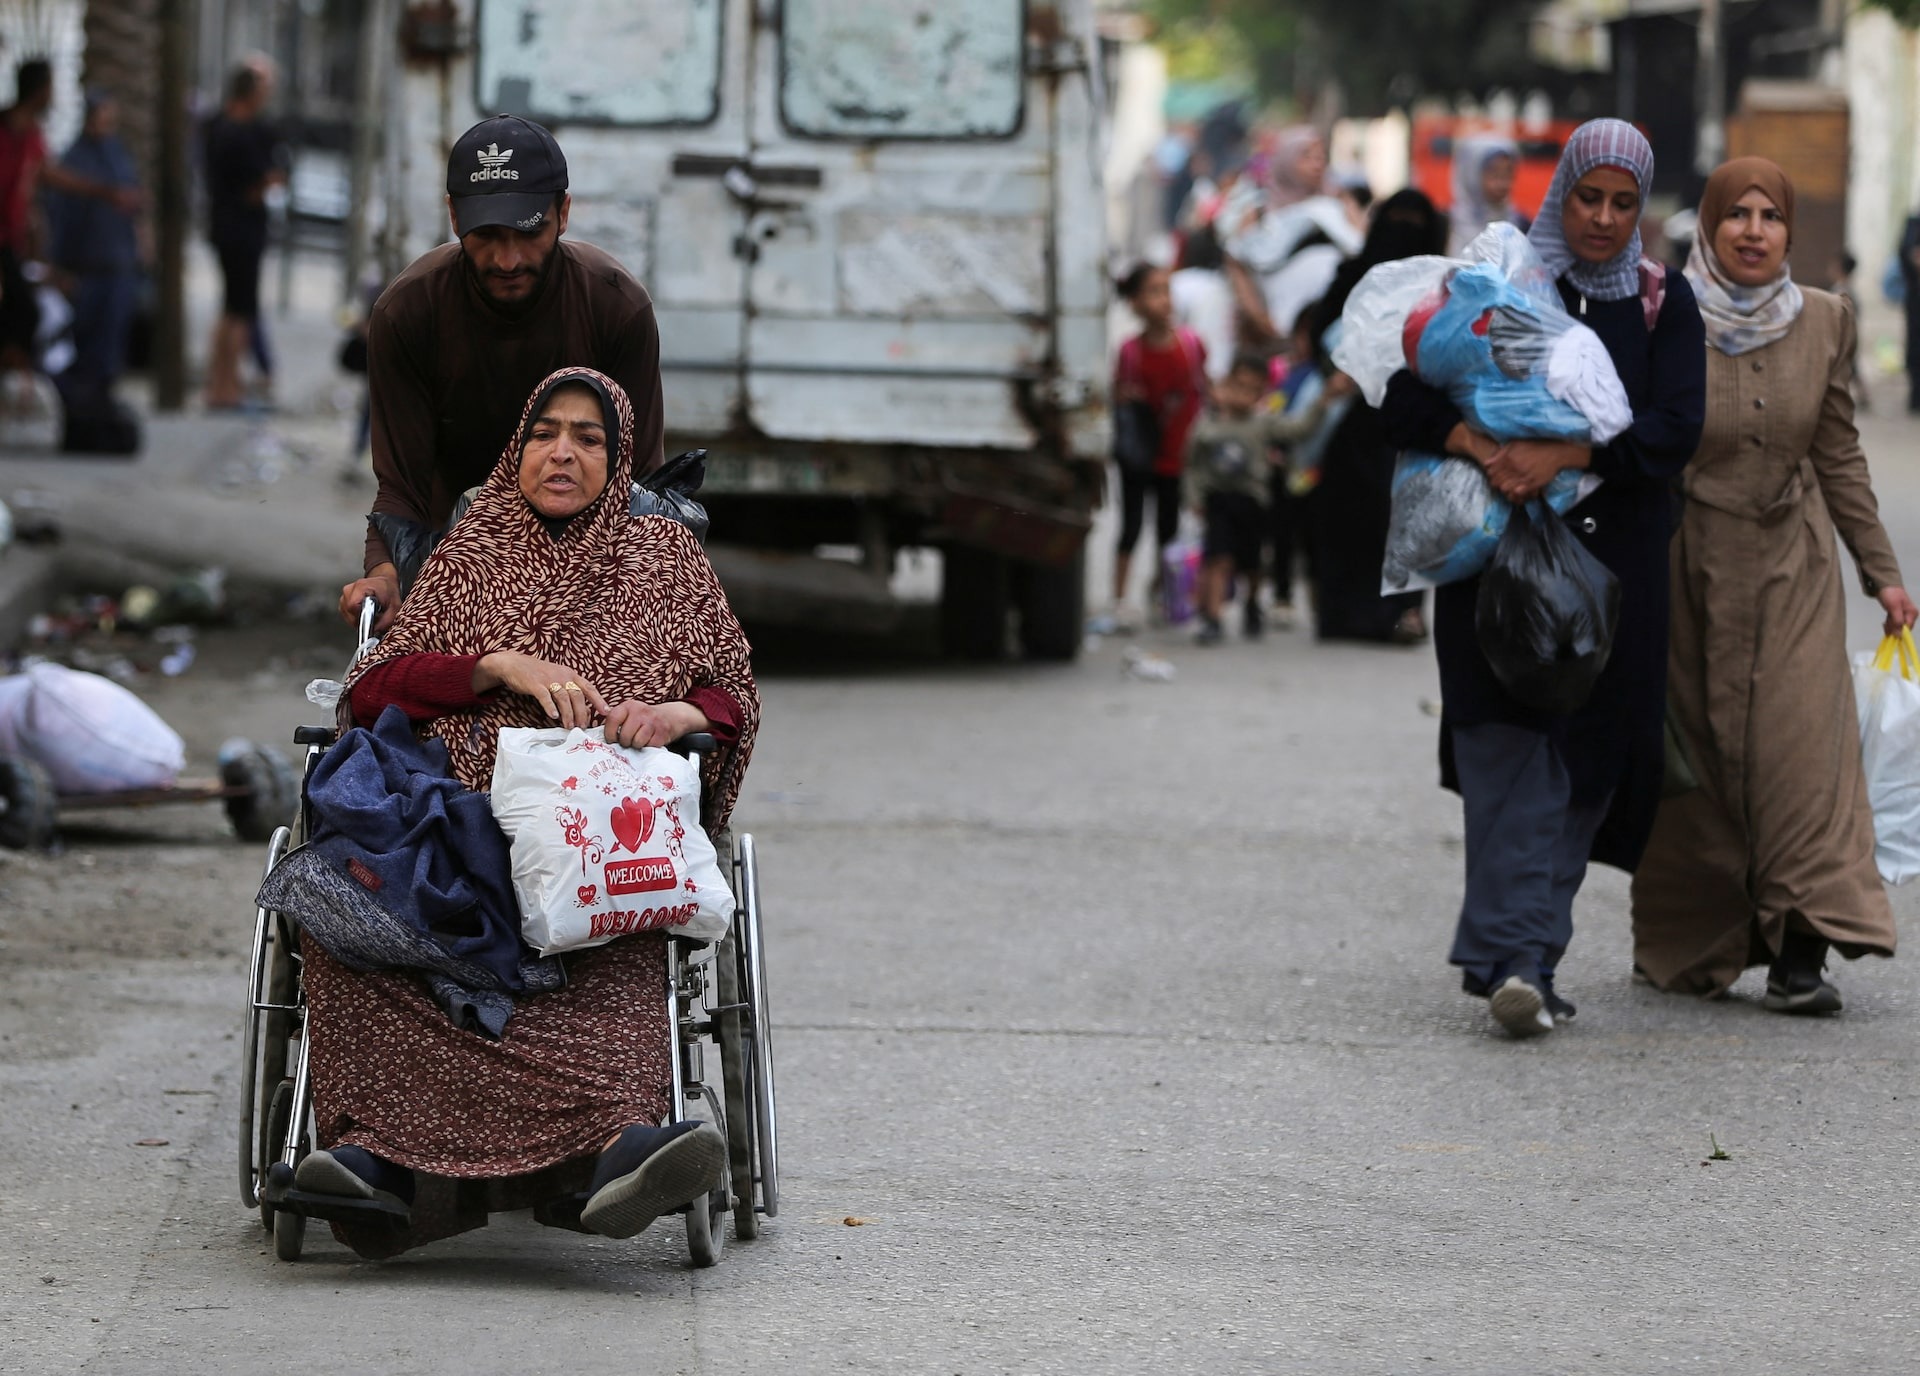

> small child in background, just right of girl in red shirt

[{"left": 1185, "top": 355, "right": 1354, "bottom": 645}]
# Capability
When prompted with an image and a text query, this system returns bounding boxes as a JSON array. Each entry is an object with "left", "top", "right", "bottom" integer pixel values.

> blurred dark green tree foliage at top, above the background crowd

[{"left": 1144, "top": 0, "right": 1543, "bottom": 113}]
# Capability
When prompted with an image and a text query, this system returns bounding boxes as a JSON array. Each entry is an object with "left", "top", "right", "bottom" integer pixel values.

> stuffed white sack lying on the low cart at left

[{"left": 13, "top": 664, "right": 186, "bottom": 793}]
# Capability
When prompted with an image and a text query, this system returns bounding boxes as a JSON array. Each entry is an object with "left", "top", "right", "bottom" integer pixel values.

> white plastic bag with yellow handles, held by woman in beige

[{"left": 1853, "top": 631, "right": 1920, "bottom": 885}]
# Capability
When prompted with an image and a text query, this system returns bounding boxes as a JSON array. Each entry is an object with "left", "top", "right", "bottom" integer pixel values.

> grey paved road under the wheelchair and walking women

[{"left": 0, "top": 412, "right": 1920, "bottom": 1376}]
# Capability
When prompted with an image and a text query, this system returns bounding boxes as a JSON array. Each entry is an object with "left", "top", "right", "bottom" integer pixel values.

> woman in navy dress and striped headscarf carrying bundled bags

[{"left": 1382, "top": 119, "right": 1707, "bottom": 1036}]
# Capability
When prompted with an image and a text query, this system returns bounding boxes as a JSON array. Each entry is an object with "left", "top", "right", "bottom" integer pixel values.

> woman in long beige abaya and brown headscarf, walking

[{"left": 1634, "top": 157, "right": 1914, "bottom": 1013}]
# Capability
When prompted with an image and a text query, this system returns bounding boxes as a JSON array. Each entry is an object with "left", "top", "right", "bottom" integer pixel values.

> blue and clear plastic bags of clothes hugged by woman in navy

[{"left": 1332, "top": 225, "right": 1634, "bottom": 593}]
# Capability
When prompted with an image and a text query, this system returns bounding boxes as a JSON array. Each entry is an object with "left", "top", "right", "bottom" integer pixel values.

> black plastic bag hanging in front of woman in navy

[{"left": 1475, "top": 501, "right": 1620, "bottom": 716}]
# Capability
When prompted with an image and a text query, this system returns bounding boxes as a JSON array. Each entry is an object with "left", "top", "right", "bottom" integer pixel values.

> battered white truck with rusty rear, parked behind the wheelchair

[{"left": 388, "top": 0, "right": 1108, "bottom": 658}]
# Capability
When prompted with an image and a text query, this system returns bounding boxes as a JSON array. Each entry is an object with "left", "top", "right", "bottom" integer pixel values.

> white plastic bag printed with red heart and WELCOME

[{"left": 493, "top": 727, "right": 733, "bottom": 956}]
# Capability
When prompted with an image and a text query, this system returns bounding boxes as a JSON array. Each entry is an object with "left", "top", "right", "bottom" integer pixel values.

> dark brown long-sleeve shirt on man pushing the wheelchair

[{"left": 367, "top": 240, "right": 664, "bottom": 570}]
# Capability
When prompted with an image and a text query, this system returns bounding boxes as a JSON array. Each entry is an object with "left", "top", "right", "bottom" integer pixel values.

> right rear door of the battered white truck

[{"left": 741, "top": 0, "right": 1052, "bottom": 449}]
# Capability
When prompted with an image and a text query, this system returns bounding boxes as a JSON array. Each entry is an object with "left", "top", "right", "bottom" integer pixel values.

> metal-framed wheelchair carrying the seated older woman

[{"left": 240, "top": 599, "right": 780, "bottom": 1267}]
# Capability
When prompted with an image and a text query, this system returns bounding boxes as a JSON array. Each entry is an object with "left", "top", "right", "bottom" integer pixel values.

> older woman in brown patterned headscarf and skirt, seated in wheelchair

[{"left": 296, "top": 368, "right": 758, "bottom": 1255}]
